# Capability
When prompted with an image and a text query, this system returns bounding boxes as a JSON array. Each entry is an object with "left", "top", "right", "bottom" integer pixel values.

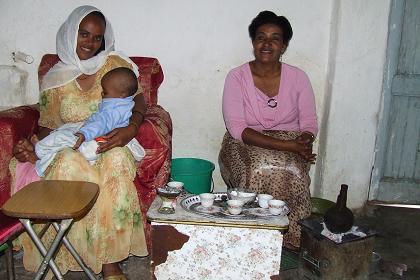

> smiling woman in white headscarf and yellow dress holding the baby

[{"left": 11, "top": 6, "right": 148, "bottom": 279}]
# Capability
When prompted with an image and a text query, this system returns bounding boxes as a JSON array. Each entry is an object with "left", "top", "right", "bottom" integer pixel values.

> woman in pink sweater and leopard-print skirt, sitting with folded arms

[{"left": 219, "top": 11, "right": 318, "bottom": 248}]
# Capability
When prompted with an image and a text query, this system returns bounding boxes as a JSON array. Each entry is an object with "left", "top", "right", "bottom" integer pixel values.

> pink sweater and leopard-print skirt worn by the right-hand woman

[{"left": 219, "top": 63, "right": 318, "bottom": 247}]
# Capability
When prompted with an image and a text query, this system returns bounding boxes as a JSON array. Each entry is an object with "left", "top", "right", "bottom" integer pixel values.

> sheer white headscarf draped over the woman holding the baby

[{"left": 40, "top": 6, "right": 139, "bottom": 92}]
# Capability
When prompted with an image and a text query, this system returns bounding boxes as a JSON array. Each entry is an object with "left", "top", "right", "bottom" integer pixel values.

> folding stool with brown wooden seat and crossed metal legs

[{"left": 2, "top": 180, "right": 99, "bottom": 279}]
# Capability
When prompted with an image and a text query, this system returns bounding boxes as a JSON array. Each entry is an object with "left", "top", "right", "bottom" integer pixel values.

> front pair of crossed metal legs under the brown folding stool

[{"left": 19, "top": 219, "right": 73, "bottom": 280}]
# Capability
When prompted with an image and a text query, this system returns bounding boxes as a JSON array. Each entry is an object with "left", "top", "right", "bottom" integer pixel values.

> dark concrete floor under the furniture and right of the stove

[{"left": 0, "top": 206, "right": 420, "bottom": 280}]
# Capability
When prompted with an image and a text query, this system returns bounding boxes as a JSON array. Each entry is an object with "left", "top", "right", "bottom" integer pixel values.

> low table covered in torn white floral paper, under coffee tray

[{"left": 147, "top": 196, "right": 289, "bottom": 280}]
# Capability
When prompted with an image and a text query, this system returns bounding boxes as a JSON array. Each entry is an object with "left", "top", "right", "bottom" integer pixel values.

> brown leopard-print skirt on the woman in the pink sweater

[{"left": 219, "top": 131, "right": 311, "bottom": 247}]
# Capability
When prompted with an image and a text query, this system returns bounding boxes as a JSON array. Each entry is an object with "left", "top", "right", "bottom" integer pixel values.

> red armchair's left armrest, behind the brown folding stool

[{"left": 0, "top": 105, "right": 39, "bottom": 205}]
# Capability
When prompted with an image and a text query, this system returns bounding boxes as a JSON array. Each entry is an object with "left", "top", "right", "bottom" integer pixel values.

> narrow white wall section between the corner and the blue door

[{"left": 316, "top": 0, "right": 390, "bottom": 208}]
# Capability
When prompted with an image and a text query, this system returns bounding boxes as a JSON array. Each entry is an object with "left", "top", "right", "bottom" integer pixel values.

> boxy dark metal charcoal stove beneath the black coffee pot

[{"left": 298, "top": 218, "right": 375, "bottom": 280}]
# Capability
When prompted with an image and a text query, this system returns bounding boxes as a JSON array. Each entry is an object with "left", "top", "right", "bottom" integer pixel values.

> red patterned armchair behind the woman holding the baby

[{"left": 0, "top": 54, "right": 172, "bottom": 248}]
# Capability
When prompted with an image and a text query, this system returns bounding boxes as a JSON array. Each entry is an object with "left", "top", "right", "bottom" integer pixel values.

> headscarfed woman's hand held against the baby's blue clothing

[{"left": 97, "top": 123, "right": 138, "bottom": 154}]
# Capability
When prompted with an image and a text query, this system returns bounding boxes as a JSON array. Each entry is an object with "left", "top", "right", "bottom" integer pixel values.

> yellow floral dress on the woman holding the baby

[{"left": 11, "top": 56, "right": 148, "bottom": 278}]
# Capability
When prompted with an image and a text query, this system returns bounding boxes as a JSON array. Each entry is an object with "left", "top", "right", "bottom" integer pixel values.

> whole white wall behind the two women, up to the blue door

[{"left": 0, "top": 0, "right": 389, "bottom": 206}]
